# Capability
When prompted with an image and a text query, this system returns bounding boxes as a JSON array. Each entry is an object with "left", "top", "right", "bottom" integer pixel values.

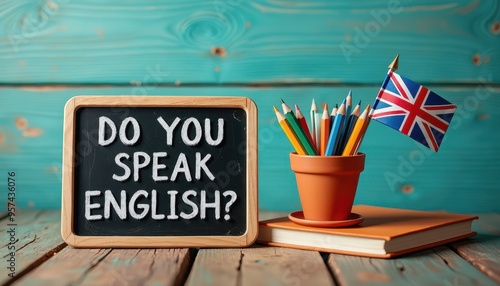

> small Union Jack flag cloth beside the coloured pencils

[{"left": 370, "top": 71, "right": 457, "bottom": 152}]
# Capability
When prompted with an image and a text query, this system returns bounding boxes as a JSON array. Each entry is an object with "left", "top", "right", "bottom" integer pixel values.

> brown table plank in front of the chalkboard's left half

[{"left": 16, "top": 246, "right": 190, "bottom": 285}]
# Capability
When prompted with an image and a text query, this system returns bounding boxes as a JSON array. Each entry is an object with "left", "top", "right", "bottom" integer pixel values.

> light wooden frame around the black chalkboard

[{"left": 61, "top": 96, "right": 258, "bottom": 248}]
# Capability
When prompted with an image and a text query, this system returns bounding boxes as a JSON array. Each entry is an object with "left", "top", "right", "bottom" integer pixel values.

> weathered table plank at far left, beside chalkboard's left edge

[{"left": 0, "top": 210, "right": 66, "bottom": 284}]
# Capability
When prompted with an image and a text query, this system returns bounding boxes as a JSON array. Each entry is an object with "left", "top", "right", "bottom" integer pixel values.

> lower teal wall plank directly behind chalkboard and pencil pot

[{"left": 0, "top": 85, "right": 500, "bottom": 213}]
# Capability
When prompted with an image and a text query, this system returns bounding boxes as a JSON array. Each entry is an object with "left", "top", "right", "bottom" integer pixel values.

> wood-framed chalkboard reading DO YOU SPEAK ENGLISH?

[{"left": 61, "top": 96, "right": 258, "bottom": 247}]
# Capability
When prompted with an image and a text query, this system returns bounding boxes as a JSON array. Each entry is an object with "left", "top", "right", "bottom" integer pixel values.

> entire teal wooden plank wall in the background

[{"left": 0, "top": 0, "right": 500, "bottom": 212}]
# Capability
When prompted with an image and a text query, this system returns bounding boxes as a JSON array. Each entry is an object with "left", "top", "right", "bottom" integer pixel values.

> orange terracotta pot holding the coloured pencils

[{"left": 290, "top": 153, "right": 365, "bottom": 221}]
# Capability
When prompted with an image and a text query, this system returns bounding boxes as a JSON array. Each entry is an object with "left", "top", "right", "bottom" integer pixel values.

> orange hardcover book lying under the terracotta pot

[{"left": 257, "top": 205, "right": 478, "bottom": 258}]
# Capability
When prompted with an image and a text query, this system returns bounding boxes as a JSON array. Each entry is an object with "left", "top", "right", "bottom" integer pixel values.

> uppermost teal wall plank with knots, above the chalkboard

[{"left": 0, "top": 0, "right": 500, "bottom": 85}]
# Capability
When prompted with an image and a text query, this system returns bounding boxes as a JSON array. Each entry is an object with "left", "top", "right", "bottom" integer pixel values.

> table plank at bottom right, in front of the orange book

[{"left": 328, "top": 246, "right": 497, "bottom": 286}]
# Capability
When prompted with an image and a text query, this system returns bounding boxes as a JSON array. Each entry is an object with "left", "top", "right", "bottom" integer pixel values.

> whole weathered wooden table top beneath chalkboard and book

[{"left": 0, "top": 210, "right": 500, "bottom": 285}]
